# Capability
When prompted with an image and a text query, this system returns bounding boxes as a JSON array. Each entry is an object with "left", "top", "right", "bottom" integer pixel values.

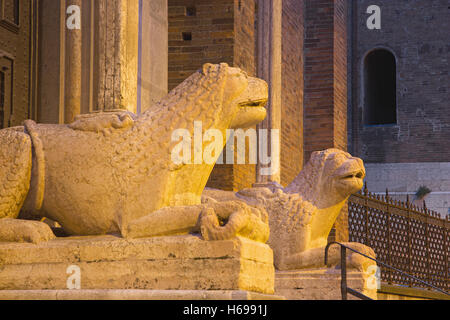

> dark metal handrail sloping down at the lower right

[{"left": 325, "top": 242, "right": 450, "bottom": 300}]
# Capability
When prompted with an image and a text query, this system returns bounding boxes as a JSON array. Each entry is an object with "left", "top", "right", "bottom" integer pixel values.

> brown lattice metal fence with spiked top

[{"left": 348, "top": 185, "right": 450, "bottom": 291}]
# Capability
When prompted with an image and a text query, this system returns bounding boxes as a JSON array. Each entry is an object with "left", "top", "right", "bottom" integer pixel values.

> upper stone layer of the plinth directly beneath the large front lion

[{"left": 0, "top": 235, "right": 273, "bottom": 265}]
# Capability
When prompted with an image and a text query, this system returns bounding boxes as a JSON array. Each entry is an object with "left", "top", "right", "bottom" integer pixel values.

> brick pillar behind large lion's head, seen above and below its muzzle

[{"left": 168, "top": 0, "right": 256, "bottom": 190}]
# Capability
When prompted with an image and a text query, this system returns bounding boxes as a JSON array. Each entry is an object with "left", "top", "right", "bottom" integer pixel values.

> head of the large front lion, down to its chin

[{"left": 141, "top": 63, "right": 268, "bottom": 135}]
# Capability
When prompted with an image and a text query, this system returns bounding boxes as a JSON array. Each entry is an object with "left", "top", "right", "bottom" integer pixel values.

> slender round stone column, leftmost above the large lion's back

[{"left": 64, "top": 0, "right": 83, "bottom": 123}]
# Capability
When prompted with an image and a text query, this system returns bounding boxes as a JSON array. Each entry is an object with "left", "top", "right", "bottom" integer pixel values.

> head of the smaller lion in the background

[{"left": 285, "top": 149, "right": 366, "bottom": 208}]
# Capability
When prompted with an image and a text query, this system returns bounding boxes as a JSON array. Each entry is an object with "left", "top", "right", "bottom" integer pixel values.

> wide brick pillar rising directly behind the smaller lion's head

[{"left": 304, "top": 0, "right": 347, "bottom": 161}]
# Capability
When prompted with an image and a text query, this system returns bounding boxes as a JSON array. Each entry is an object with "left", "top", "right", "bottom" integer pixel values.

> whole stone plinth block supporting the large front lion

[{"left": 0, "top": 235, "right": 275, "bottom": 294}]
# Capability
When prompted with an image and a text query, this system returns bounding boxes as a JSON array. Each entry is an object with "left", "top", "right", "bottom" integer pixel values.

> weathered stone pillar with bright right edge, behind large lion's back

[{"left": 95, "top": 0, "right": 139, "bottom": 112}]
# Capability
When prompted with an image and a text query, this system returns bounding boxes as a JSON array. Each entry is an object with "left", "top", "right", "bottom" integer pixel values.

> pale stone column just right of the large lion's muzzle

[{"left": 255, "top": 0, "right": 282, "bottom": 186}]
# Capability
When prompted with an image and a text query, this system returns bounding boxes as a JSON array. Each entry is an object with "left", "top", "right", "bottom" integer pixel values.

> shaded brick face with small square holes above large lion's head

[{"left": 168, "top": 0, "right": 234, "bottom": 90}]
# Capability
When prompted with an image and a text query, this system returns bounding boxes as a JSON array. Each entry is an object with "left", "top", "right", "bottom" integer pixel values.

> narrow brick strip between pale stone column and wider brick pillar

[{"left": 280, "top": 0, "right": 304, "bottom": 186}]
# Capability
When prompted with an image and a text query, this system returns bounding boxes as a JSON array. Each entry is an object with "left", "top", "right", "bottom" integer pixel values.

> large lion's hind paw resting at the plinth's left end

[{"left": 0, "top": 219, "right": 56, "bottom": 244}]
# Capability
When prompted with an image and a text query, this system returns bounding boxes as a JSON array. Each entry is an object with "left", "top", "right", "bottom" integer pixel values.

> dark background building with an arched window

[{"left": 349, "top": 0, "right": 450, "bottom": 214}]
